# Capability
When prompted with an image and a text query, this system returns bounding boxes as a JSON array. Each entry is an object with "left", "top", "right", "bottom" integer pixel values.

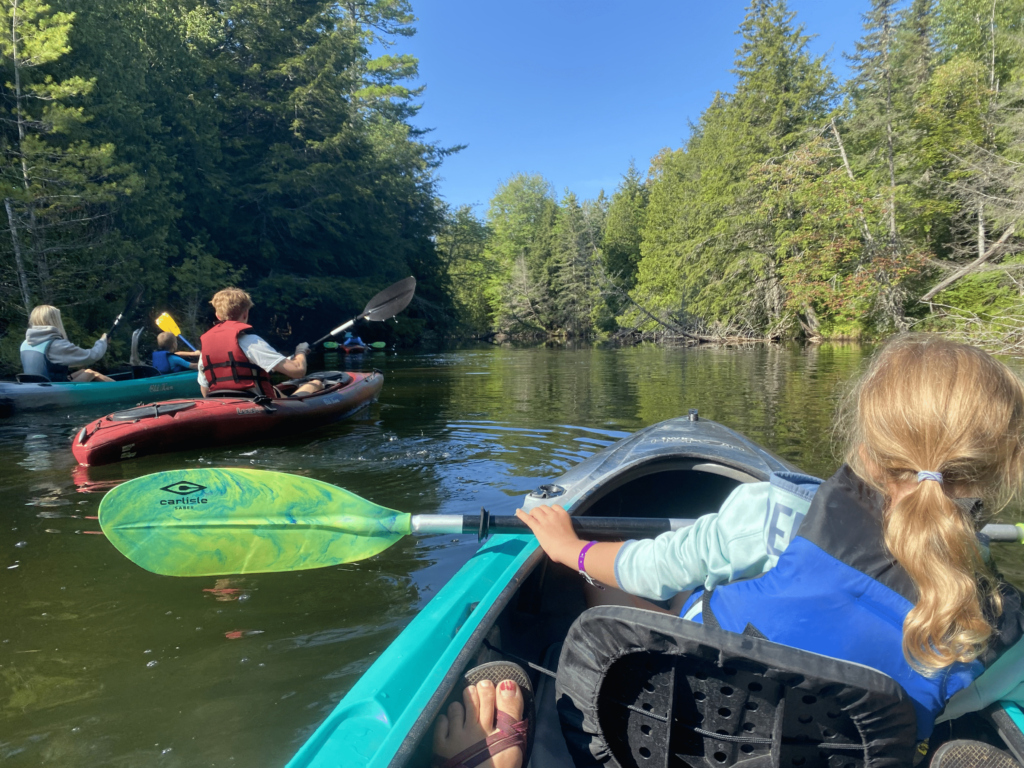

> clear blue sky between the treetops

[{"left": 395, "top": 0, "right": 870, "bottom": 211}]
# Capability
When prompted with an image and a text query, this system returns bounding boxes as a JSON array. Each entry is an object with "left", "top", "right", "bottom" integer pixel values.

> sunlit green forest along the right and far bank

[{"left": 446, "top": 0, "right": 1024, "bottom": 351}]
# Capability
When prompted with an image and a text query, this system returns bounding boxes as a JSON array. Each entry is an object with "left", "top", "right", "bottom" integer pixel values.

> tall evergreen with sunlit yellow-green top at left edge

[{"left": 0, "top": 0, "right": 136, "bottom": 312}]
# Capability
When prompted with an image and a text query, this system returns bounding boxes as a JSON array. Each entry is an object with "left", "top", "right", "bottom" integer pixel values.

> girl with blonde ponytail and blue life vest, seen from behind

[{"left": 516, "top": 335, "right": 1024, "bottom": 739}]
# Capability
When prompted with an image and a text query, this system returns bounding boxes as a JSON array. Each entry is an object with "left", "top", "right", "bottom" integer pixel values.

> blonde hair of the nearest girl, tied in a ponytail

[{"left": 845, "top": 335, "right": 1024, "bottom": 672}]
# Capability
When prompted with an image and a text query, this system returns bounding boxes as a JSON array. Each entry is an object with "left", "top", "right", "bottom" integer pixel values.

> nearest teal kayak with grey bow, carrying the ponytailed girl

[{"left": 288, "top": 412, "right": 1024, "bottom": 768}]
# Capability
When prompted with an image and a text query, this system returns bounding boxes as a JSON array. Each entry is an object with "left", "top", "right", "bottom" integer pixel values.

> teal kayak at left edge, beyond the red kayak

[{"left": 0, "top": 371, "right": 200, "bottom": 417}]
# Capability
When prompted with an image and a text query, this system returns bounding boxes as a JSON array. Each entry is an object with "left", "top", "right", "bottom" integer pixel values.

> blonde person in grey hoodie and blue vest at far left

[{"left": 22, "top": 304, "right": 114, "bottom": 382}]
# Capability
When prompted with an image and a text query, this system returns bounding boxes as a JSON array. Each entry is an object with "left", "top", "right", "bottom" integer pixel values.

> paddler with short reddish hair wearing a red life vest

[{"left": 199, "top": 288, "right": 324, "bottom": 398}]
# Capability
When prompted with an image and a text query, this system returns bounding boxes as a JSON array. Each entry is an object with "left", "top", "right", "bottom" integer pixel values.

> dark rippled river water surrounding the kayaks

[{"left": 0, "top": 345, "right": 1024, "bottom": 768}]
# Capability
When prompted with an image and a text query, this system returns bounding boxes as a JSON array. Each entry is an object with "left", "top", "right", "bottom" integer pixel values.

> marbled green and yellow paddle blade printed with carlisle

[{"left": 99, "top": 469, "right": 410, "bottom": 577}]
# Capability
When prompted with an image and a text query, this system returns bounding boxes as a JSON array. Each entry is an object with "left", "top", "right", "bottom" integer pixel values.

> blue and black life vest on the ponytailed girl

[{"left": 682, "top": 466, "right": 1021, "bottom": 738}]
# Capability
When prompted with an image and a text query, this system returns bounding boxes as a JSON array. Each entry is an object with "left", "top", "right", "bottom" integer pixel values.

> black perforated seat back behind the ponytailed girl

[{"left": 555, "top": 606, "right": 916, "bottom": 768}]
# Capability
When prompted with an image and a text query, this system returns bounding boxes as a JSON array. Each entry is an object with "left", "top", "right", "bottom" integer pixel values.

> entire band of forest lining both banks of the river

[{"left": 0, "top": 0, "right": 1024, "bottom": 373}]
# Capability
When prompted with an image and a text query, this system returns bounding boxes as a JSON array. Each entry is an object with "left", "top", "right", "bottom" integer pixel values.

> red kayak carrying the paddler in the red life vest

[{"left": 72, "top": 371, "right": 384, "bottom": 466}]
